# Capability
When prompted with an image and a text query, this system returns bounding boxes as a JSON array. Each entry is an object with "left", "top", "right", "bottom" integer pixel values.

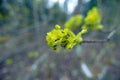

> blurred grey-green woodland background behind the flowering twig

[{"left": 0, "top": 0, "right": 120, "bottom": 80}]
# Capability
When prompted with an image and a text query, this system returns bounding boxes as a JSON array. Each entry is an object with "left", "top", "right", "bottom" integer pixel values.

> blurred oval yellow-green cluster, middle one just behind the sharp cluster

[{"left": 64, "top": 15, "right": 83, "bottom": 30}]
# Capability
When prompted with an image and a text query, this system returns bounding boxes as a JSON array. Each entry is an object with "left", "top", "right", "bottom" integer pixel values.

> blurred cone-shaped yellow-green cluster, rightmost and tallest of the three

[{"left": 82, "top": 7, "right": 103, "bottom": 31}]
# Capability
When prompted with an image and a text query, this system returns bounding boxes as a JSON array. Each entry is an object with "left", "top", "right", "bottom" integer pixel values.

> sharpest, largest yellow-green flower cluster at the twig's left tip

[{"left": 46, "top": 25, "right": 86, "bottom": 50}]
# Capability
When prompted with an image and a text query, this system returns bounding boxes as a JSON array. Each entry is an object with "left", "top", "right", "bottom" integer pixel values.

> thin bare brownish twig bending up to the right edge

[{"left": 82, "top": 27, "right": 120, "bottom": 43}]
